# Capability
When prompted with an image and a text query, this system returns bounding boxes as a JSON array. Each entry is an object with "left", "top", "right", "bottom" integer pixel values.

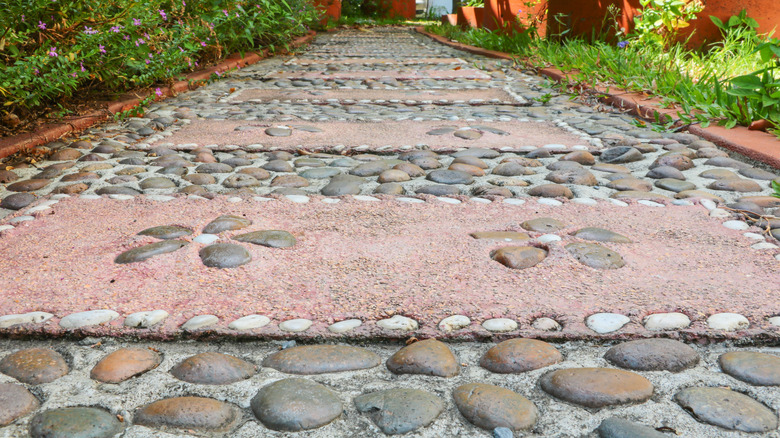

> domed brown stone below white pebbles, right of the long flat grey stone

[{"left": 387, "top": 339, "right": 460, "bottom": 377}]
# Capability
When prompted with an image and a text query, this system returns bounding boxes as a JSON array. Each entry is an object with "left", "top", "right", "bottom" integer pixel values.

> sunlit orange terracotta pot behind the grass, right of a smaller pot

[{"left": 482, "top": 0, "right": 547, "bottom": 35}]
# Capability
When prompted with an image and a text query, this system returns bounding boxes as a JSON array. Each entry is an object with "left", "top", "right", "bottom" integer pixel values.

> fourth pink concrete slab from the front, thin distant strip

[{"left": 265, "top": 68, "right": 490, "bottom": 81}]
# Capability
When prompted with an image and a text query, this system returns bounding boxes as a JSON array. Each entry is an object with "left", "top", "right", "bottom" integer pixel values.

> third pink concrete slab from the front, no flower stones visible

[{"left": 230, "top": 88, "right": 518, "bottom": 105}]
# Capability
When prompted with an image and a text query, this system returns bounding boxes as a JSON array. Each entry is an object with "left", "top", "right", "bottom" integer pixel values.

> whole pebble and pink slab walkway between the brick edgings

[{"left": 0, "top": 28, "right": 780, "bottom": 437}]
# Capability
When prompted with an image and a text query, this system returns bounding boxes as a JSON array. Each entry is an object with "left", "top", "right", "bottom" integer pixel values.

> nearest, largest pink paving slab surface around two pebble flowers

[{"left": 0, "top": 197, "right": 780, "bottom": 336}]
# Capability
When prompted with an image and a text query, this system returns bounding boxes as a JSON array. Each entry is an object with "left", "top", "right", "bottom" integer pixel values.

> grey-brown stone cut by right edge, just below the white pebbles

[{"left": 718, "top": 351, "right": 780, "bottom": 386}]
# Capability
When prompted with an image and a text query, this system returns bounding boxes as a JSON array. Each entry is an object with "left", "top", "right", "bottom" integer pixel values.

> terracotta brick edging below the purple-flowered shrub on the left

[{"left": 0, "top": 30, "right": 317, "bottom": 158}]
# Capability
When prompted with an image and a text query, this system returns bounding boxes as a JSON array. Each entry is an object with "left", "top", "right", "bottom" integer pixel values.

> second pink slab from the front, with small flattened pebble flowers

[{"left": 149, "top": 120, "right": 582, "bottom": 152}]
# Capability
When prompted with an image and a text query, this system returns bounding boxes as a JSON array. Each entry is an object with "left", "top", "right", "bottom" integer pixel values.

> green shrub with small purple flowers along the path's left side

[{"left": 0, "top": 0, "right": 317, "bottom": 118}]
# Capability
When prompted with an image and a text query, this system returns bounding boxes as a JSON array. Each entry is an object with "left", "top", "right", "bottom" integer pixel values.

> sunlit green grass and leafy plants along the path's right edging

[{"left": 426, "top": 21, "right": 780, "bottom": 135}]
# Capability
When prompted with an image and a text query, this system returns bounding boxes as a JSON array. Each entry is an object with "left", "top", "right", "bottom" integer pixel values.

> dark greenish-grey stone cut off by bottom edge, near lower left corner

[{"left": 30, "top": 407, "right": 124, "bottom": 438}]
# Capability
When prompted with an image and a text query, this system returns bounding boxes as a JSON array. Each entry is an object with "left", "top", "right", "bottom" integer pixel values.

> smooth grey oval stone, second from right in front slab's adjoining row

[{"left": 604, "top": 338, "right": 699, "bottom": 373}]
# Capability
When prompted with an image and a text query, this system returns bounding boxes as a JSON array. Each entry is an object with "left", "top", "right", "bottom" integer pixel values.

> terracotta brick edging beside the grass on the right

[{"left": 415, "top": 27, "right": 780, "bottom": 169}]
